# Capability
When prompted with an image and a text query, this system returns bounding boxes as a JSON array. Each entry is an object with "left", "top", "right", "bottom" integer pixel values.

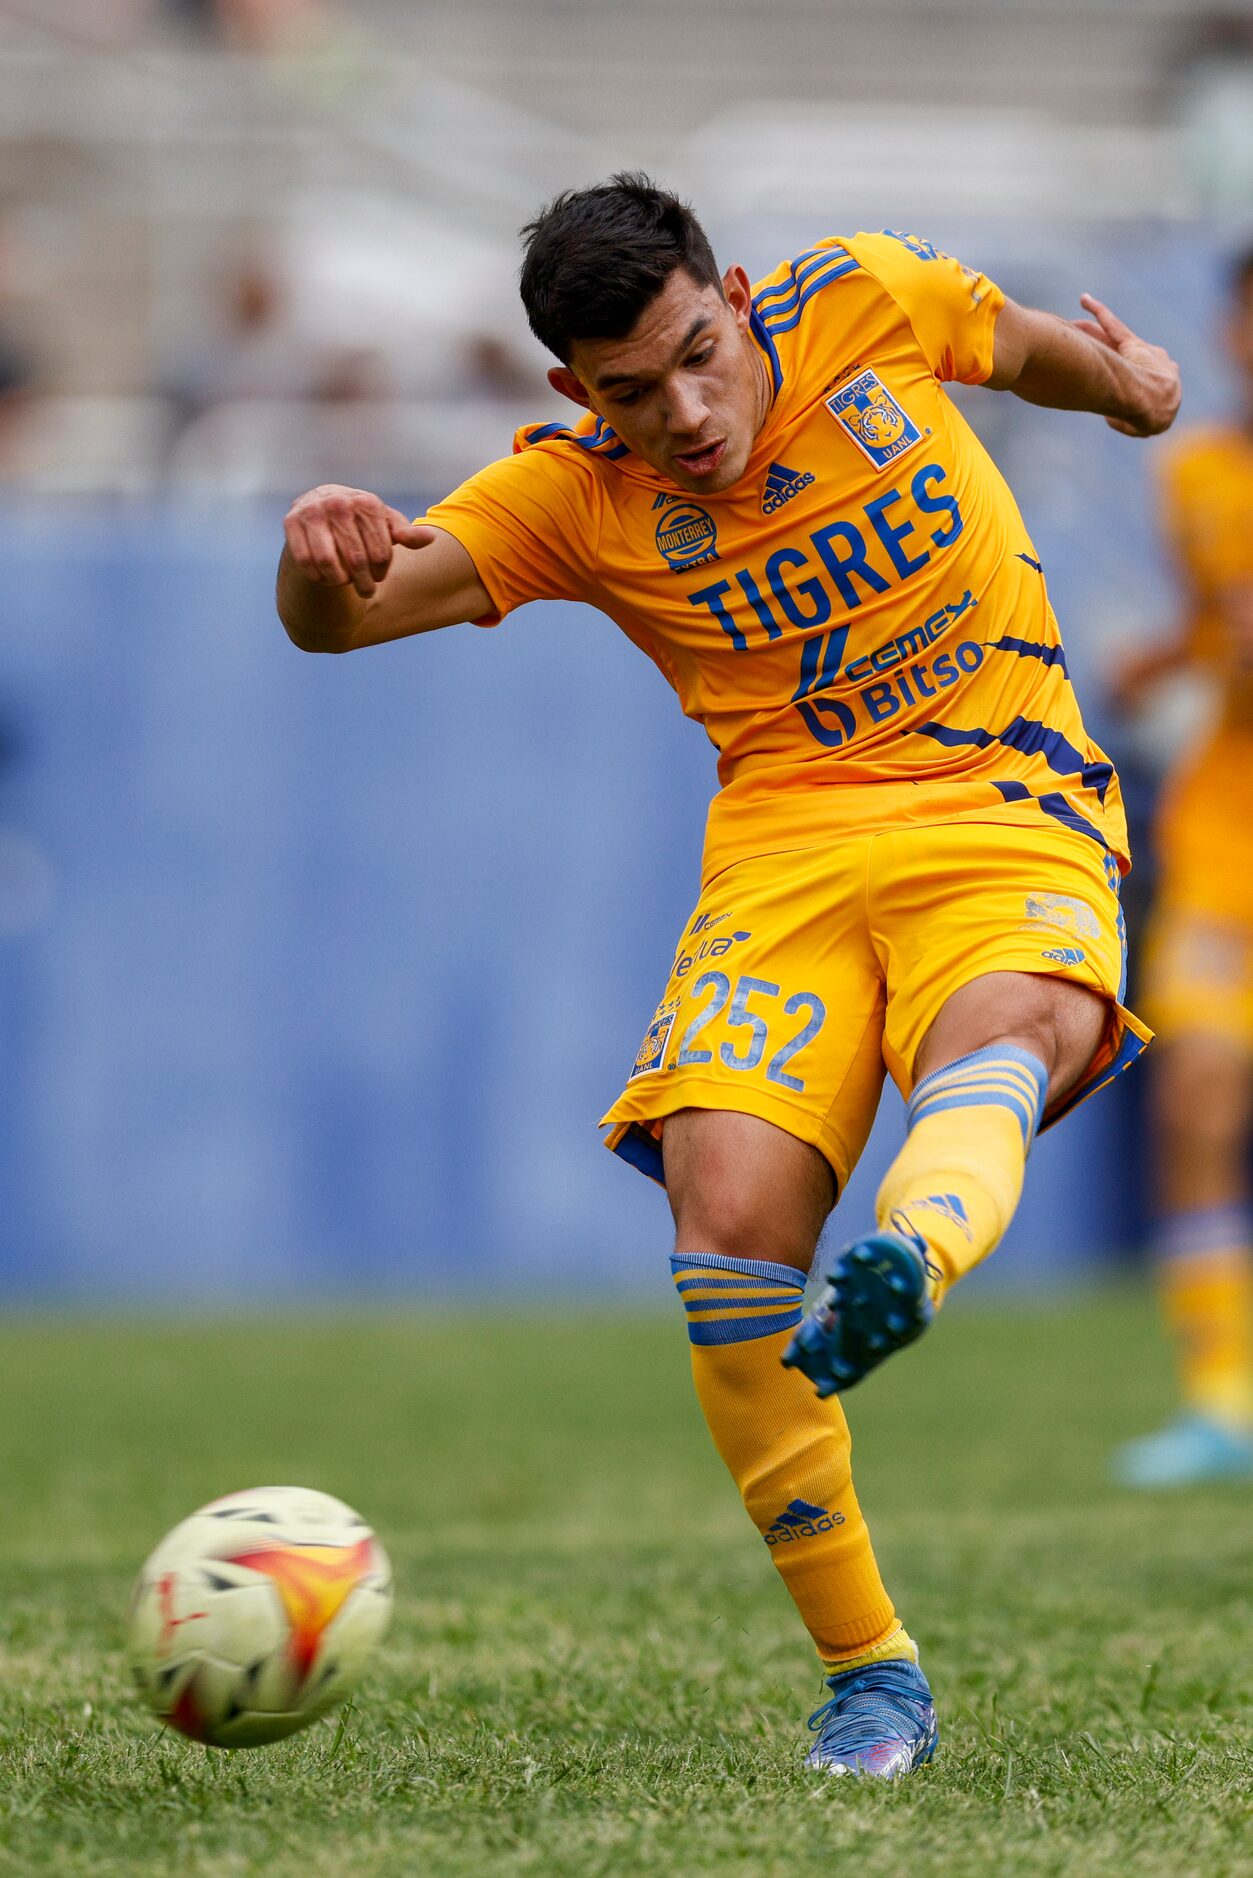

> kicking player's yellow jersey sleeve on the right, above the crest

[{"left": 843, "top": 229, "right": 1005, "bottom": 385}]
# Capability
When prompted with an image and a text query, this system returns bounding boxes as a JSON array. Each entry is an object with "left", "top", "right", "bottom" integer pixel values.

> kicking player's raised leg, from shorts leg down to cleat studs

[{"left": 785, "top": 821, "right": 1142, "bottom": 1393}]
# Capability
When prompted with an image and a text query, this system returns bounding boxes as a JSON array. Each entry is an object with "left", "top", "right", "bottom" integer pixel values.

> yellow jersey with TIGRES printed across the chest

[{"left": 426, "top": 229, "right": 1127, "bottom": 881}]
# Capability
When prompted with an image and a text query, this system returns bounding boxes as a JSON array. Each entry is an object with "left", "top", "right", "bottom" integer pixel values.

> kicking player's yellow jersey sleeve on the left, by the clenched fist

[{"left": 419, "top": 449, "right": 599, "bottom": 625}]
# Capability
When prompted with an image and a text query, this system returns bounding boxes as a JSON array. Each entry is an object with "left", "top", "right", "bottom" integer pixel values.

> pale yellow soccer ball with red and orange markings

[{"left": 128, "top": 1487, "right": 391, "bottom": 1748}]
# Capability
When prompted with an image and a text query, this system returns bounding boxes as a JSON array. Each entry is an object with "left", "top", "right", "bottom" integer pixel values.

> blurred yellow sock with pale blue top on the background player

[{"left": 1155, "top": 1206, "right": 1253, "bottom": 1425}]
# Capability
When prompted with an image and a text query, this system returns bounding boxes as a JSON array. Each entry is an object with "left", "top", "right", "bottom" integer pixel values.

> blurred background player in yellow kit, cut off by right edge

[{"left": 1114, "top": 252, "right": 1253, "bottom": 1487}]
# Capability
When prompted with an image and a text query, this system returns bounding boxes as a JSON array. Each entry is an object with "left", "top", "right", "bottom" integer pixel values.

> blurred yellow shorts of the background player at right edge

[{"left": 1144, "top": 731, "right": 1253, "bottom": 1050}]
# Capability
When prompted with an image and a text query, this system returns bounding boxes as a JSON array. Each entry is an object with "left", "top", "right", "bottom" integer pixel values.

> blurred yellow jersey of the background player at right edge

[{"left": 1163, "top": 424, "right": 1253, "bottom": 731}]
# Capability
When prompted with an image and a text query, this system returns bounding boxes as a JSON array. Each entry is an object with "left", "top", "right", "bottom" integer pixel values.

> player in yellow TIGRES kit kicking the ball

[{"left": 278, "top": 175, "right": 1180, "bottom": 1778}]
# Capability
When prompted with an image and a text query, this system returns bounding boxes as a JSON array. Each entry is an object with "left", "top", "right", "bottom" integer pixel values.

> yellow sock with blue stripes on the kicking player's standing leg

[{"left": 671, "top": 1253, "right": 917, "bottom": 1670}]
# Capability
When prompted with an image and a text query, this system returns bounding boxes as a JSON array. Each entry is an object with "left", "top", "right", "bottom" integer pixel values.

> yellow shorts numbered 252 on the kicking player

[{"left": 601, "top": 809, "right": 1152, "bottom": 1189}]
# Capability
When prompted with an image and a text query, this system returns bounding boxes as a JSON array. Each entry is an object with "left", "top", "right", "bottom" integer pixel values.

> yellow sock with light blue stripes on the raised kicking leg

[{"left": 875, "top": 1044, "right": 1048, "bottom": 1303}]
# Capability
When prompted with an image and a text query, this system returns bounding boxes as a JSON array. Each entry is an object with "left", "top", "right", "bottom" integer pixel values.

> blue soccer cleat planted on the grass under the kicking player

[{"left": 806, "top": 1660, "right": 939, "bottom": 1780}]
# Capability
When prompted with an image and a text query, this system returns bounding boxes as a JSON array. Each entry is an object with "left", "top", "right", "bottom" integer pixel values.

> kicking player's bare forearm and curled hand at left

[{"left": 278, "top": 483, "right": 492, "bottom": 652}]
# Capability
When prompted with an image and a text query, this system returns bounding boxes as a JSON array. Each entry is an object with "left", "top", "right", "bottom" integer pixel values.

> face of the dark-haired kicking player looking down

[{"left": 549, "top": 267, "right": 770, "bottom": 494}]
